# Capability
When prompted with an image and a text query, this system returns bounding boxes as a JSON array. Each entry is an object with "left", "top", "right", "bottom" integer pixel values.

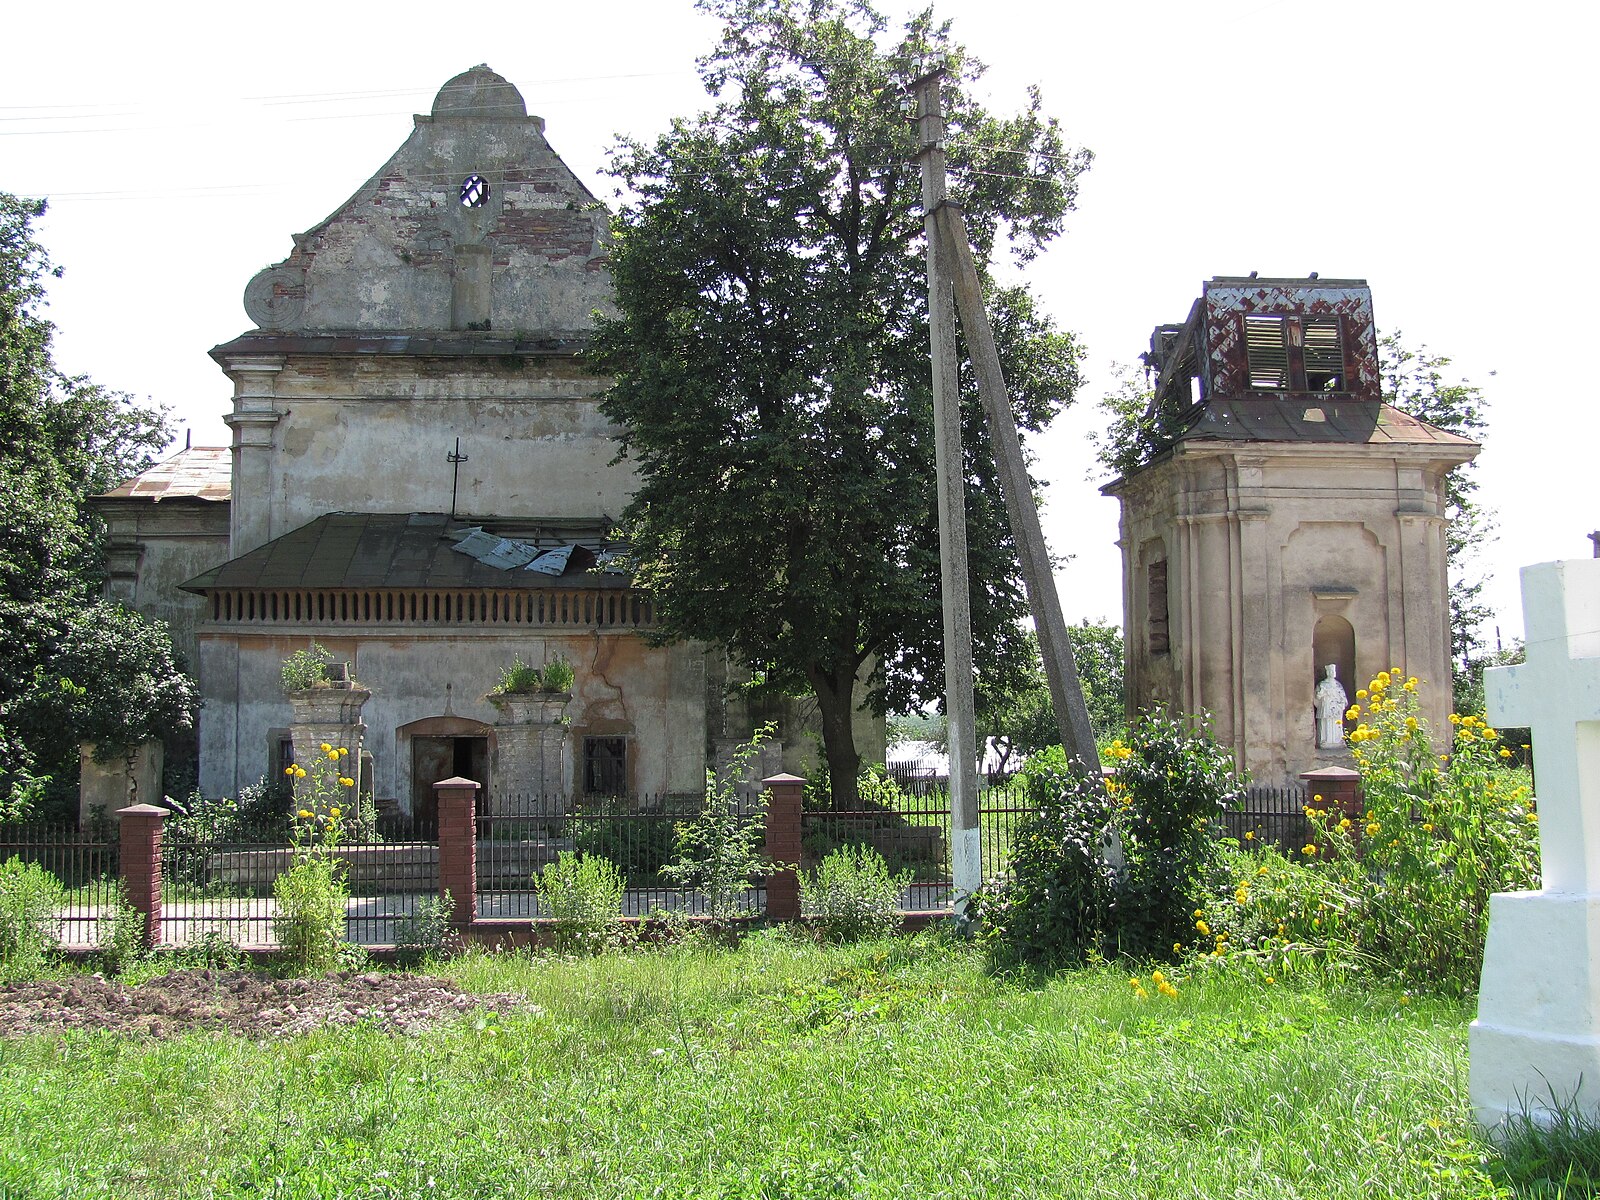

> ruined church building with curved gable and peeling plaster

[{"left": 99, "top": 66, "right": 883, "bottom": 818}]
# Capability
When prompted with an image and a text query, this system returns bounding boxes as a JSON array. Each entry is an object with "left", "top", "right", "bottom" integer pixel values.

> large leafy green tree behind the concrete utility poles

[{"left": 590, "top": 0, "right": 1088, "bottom": 806}]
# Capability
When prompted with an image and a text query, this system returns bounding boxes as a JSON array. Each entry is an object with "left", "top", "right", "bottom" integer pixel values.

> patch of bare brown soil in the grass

[{"left": 0, "top": 970, "right": 533, "bottom": 1037}]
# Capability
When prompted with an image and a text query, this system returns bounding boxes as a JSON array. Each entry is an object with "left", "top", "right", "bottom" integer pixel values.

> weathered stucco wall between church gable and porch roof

[{"left": 211, "top": 355, "right": 617, "bottom": 557}]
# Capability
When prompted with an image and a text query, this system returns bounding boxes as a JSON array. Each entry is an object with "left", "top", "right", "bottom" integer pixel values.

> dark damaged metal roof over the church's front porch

[{"left": 182, "top": 512, "right": 620, "bottom": 592}]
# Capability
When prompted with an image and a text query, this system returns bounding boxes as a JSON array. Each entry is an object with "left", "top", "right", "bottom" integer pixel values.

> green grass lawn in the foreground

[{"left": 0, "top": 934, "right": 1568, "bottom": 1200}]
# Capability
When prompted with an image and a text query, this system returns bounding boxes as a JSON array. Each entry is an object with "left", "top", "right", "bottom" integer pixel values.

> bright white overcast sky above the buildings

[{"left": 9, "top": 0, "right": 1600, "bottom": 659}]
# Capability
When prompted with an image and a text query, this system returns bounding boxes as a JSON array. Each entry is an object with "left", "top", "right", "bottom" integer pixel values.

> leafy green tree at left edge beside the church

[{"left": 0, "top": 192, "right": 195, "bottom": 803}]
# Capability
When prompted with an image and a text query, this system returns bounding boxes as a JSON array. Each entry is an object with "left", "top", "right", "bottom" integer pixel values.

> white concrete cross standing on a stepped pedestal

[{"left": 1483, "top": 558, "right": 1600, "bottom": 894}]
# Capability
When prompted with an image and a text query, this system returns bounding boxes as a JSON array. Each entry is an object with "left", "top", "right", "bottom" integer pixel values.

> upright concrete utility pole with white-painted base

[{"left": 910, "top": 69, "right": 984, "bottom": 915}]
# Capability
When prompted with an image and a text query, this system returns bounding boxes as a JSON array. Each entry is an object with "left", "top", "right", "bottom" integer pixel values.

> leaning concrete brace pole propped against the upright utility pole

[{"left": 914, "top": 72, "right": 1099, "bottom": 774}]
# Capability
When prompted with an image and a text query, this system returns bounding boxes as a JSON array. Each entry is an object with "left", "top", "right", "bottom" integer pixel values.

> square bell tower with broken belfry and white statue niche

[{"left": 1104, "top": 275, "right": 1478, "bottom": 786}]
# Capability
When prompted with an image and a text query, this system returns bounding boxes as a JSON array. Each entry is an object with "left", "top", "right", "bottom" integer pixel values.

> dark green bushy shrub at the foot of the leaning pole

[{"left": 974, "top": 714, "right": 1240, "bottom": 970}]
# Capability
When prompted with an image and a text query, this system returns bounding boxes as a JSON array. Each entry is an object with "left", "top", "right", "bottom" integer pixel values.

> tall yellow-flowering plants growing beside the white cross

[{"left": 1186, "top": 669, "right": 1539, "bottom": 995}]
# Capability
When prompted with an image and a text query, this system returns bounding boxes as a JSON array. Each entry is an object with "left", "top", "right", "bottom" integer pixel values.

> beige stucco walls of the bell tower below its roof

[{"left": 1117, "top": 442, "right": 1461, "bottom": 786}]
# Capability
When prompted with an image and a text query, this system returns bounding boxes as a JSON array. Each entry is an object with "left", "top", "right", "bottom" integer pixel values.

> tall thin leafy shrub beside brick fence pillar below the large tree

[{"left": 661, "top": 723, "right": 774, "bottom": 920}]
